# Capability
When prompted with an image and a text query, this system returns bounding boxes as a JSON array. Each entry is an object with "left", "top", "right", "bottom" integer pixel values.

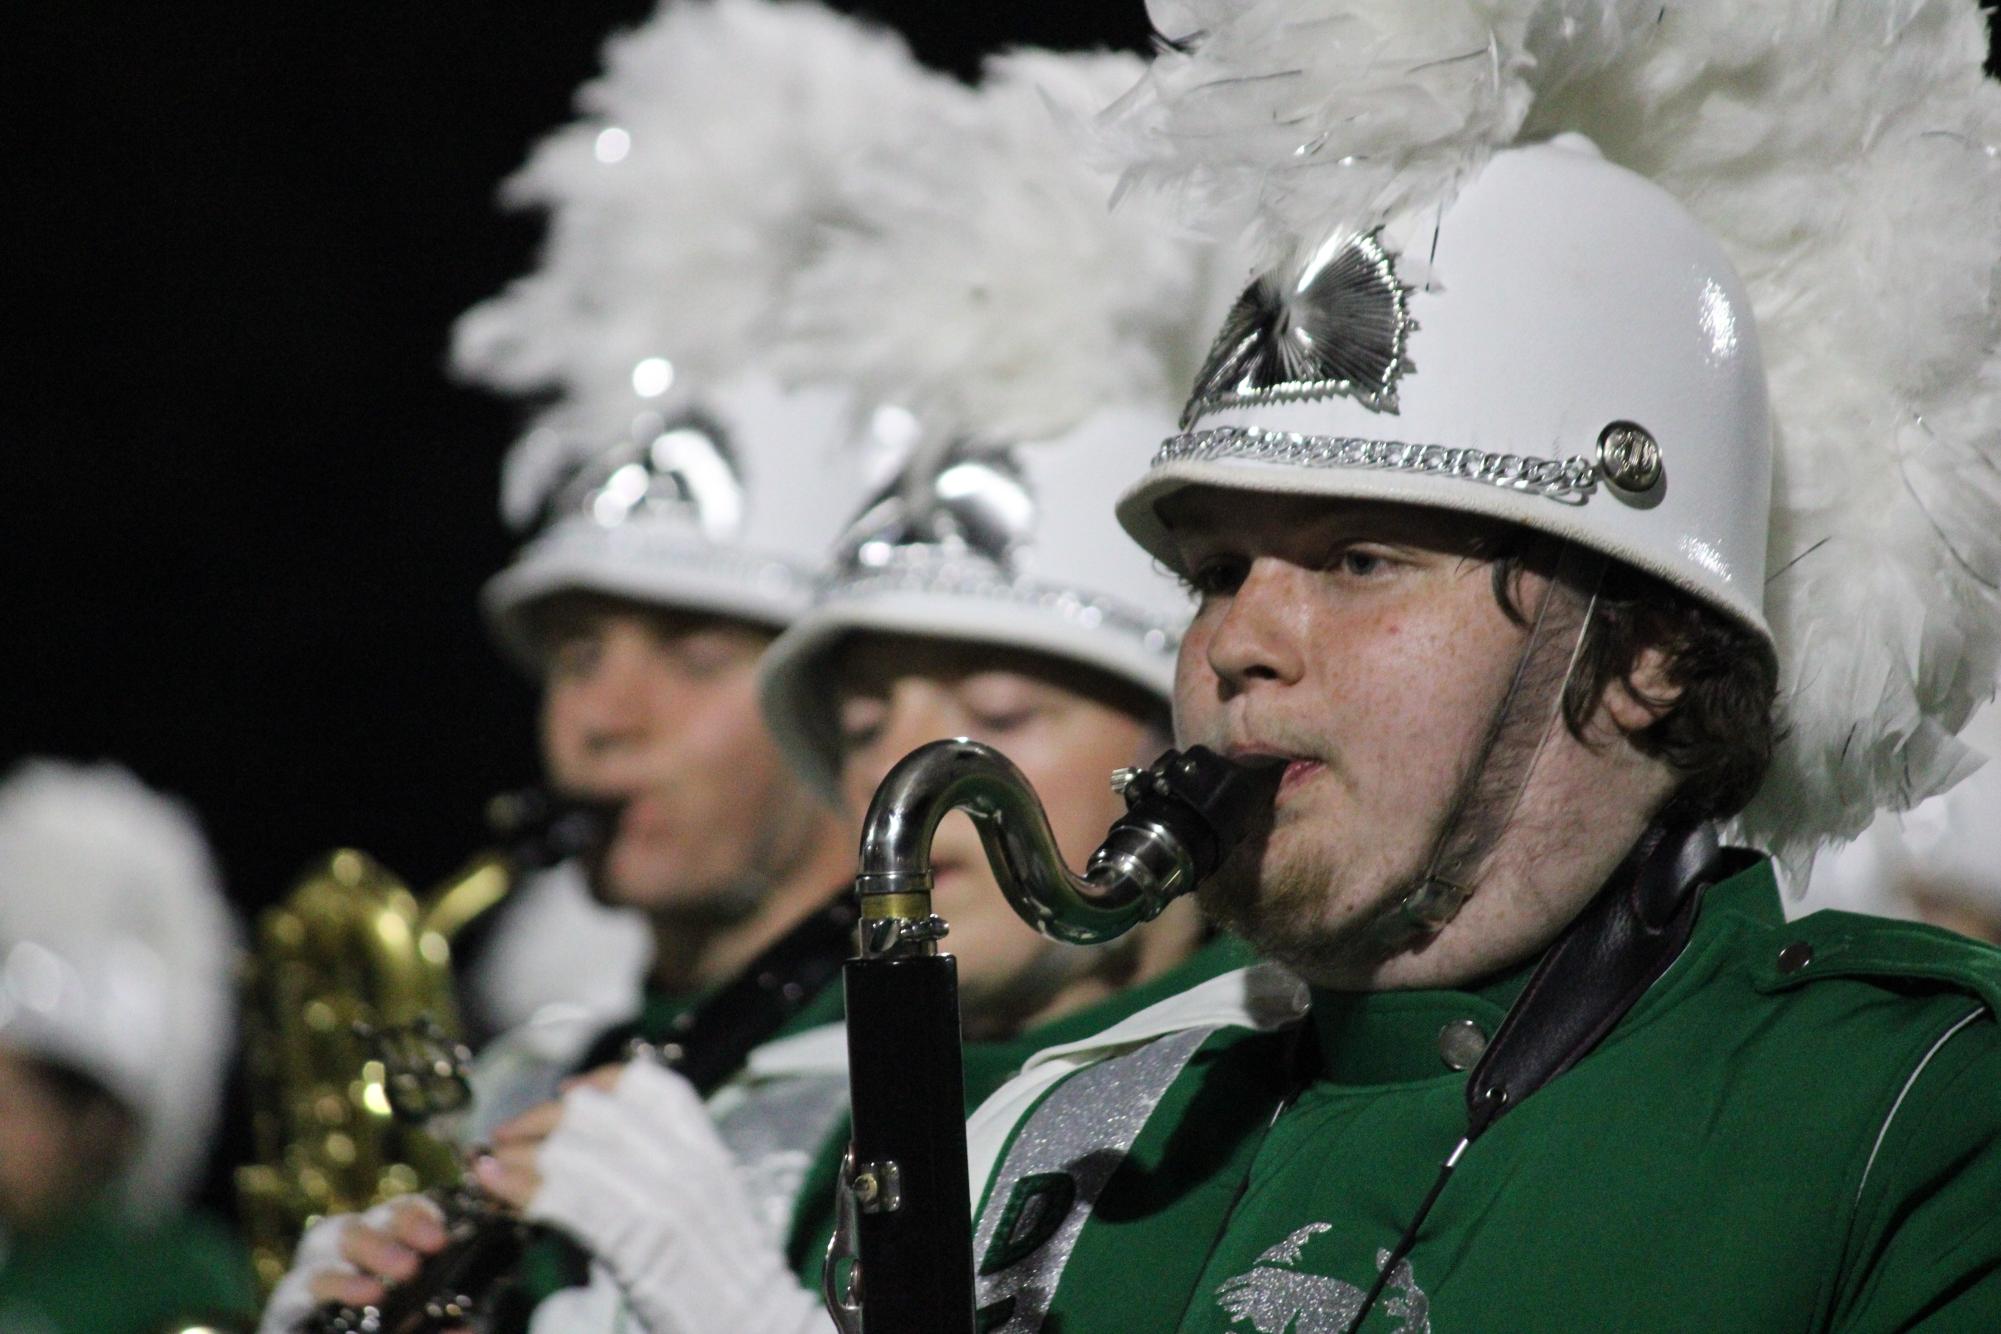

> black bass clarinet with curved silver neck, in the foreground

[{"left": 820, "top": 738, "right": 1285, "bottom": 1334}]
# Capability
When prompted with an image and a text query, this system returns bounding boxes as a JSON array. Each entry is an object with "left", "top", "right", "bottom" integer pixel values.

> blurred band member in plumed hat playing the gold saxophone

[{"left": 262, "top": 0, "right": 964, "bottom": 1332}]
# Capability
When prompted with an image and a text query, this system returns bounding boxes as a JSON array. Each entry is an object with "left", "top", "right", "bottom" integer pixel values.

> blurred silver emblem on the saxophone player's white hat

[{"left": 542, "top": 408, "right": 744, "bottom": 542}]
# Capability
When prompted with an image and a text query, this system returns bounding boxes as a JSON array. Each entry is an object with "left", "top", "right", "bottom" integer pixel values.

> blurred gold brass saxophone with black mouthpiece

[{"left": 236, "top": 792, "right": 602, "bottom": 1294}]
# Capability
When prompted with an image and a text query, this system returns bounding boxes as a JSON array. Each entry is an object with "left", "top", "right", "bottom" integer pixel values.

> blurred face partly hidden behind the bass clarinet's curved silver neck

[{"left": 836, "top": 634, "right": 1165, "bottom": 1026}]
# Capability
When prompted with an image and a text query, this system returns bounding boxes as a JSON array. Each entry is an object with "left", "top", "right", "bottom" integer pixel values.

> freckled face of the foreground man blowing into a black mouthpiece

[{"left": 1163, "top": 492, "right": 1541, "bottom": 980}]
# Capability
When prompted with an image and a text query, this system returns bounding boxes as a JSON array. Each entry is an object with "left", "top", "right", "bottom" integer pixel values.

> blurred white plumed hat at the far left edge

[{"left": 0, "top": 760, "right": 238, "bottom": 1212}]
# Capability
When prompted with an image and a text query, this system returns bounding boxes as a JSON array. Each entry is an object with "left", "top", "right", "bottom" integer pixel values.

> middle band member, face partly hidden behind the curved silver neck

[{"left": 454, "top": 44, "right": 1245, "bottom": 1334}]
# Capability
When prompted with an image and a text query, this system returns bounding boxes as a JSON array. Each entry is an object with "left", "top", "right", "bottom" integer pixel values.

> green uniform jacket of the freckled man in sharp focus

[{"left": 976, "top": 864, "right": 2001, "bottom": 1334}]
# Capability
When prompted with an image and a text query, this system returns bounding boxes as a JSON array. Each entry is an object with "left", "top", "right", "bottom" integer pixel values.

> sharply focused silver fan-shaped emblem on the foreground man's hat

[{"left": 1181, "top": 232, "right": 1417, "bottom": 428}]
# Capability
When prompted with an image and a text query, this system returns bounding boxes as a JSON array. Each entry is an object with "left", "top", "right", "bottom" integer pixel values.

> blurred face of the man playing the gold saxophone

[{"left": 536, "top": 594, "right": 818, "bottom": 920}]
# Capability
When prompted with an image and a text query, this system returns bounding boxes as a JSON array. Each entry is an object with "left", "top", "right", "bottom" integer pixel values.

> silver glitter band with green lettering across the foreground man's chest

[{"left": 972, "top": 1028, "right": 1215, "bottom": 1334}]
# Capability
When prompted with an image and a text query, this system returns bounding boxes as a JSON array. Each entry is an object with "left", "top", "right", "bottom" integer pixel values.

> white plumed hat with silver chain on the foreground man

[{"left": 1103, "top": 0, "right": 2001, "bottom": 856}]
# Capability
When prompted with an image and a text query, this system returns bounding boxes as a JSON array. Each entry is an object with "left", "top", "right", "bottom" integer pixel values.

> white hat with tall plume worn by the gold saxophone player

[{"left": 452, "top": 0, "right": 968, "bottom": 660}]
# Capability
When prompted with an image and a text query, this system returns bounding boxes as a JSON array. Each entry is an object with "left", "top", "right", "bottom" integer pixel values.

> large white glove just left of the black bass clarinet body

[{"left": 526, "top": 1062, "right": 832, "bottom": 1334}]
